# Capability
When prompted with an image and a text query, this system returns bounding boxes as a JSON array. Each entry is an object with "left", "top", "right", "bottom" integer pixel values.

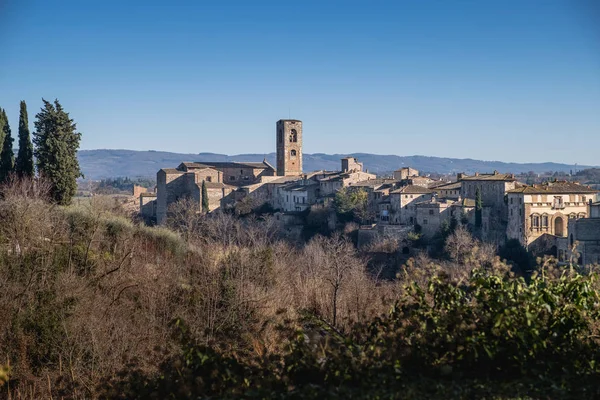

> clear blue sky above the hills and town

[{"left": 0, "top": 0, "right": 600, "bottom": 165}]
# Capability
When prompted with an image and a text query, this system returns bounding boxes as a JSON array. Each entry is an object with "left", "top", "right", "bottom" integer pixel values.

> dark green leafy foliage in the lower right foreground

[{"left": 106, "top": 270, "right": 600, "bottom": 399}]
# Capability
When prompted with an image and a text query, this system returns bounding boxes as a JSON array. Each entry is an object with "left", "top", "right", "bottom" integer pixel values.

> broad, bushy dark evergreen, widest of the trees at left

[{"left": 33, "top": 99, "right": 83, "bottom": 205}]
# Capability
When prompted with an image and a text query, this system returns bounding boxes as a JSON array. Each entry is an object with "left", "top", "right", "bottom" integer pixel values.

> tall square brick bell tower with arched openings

[{"left": 277, "top": 119, "right": 302, "bottom": 176}]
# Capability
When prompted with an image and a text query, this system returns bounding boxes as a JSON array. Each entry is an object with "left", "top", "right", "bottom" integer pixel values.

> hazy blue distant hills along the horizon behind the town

[{"left": 78, "top": 150, "right": 589, "bottom": 180}]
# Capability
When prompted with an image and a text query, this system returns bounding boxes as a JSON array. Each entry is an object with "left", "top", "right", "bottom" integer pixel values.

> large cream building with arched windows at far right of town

[{"left": 506, "top": 181, "right": 598, "bottom": 246}]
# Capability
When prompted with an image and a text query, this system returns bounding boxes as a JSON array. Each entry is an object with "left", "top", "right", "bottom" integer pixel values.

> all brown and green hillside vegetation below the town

[{"left": 0, "top": 179, "right": 600, "bottom": 399}]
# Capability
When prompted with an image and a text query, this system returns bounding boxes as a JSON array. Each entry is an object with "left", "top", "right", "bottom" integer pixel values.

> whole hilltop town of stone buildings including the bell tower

[{"left": 134, "top": 119, "right": 600, "bottom": 265}]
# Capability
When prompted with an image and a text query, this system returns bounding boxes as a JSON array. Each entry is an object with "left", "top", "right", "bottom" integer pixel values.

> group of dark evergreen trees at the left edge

[{"left": 0, "top": 99, "right": 83, "bottom": 205}]
